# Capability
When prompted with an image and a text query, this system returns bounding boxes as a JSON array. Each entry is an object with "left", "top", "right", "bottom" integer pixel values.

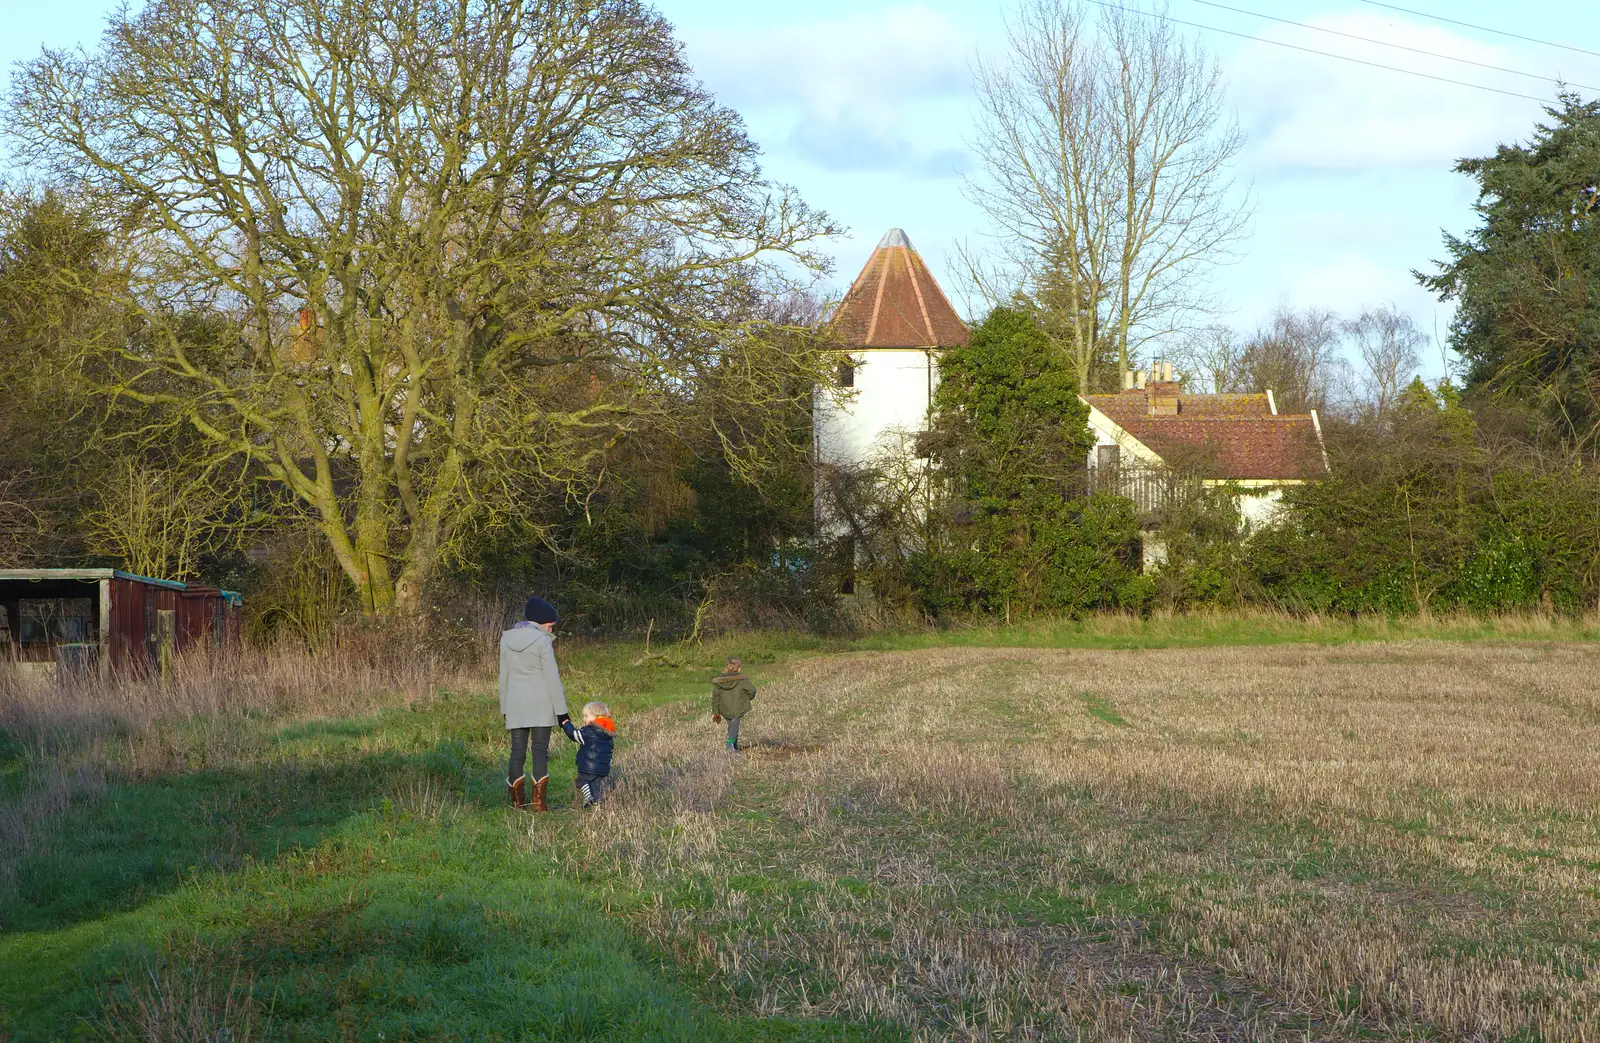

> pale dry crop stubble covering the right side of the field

[{"left": 587, "top": 641, "right": 1600, "bottom": 1041}]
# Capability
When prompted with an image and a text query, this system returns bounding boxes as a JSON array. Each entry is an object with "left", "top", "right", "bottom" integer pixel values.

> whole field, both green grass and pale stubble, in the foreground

[{"left": 0, "top": 621, "right": 1600, "bottom": 1043}]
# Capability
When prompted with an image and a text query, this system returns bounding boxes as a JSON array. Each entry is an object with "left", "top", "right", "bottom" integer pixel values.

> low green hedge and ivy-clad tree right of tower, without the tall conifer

[{"left": 826, "top": 309, "right": 1600, "bottom": 621}]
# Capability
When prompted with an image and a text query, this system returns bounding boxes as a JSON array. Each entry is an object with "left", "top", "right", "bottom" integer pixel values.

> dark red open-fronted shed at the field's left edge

[{"left": 0, "top": 568, "right": 245, "bottom": 675}]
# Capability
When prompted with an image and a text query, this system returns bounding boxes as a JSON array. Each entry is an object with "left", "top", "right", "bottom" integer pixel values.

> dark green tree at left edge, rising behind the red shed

[{"left": 0, "top": 192, "right": 269, "bottom": 581}]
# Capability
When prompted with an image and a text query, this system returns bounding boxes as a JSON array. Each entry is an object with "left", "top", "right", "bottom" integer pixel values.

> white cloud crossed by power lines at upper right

[{"left": 1229, "top": 11, "right": 1574, "bottom": 170}]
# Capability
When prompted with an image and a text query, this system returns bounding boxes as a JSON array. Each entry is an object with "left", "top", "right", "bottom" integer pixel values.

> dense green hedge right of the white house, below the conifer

[{"left": 1243, "top": 382, "right": 1600, "bottom": 616}]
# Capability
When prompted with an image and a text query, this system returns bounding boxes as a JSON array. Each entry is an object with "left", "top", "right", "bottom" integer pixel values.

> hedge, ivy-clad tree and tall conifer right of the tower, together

[{"left": 812, "top": 96, "right": 1600, "bottom": 619}]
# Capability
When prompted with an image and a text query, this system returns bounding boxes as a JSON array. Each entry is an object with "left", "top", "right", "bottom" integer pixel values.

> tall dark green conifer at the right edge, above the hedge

[{"left": 1418, "top": 94, "right": 1600, "bottom": 454}]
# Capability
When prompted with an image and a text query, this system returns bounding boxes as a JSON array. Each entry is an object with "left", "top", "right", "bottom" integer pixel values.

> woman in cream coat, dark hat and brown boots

[{"left": 499, "top": 598, "right": 571, "bottom": 811}]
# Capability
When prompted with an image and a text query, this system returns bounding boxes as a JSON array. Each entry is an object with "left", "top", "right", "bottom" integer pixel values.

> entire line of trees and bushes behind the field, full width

[{"left": 0, "top": 0, "right": 1600, "bottom": 638}]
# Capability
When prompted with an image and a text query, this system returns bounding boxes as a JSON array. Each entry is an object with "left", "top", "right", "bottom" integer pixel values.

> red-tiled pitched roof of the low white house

[{"left": 1085, "top": 392, "right": 1326, "bottom": 480}]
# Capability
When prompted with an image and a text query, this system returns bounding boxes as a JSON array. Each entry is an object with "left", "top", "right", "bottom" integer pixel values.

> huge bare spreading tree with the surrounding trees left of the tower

[{"left": 0, "top": 0, "right": 835, "bottom": 629}]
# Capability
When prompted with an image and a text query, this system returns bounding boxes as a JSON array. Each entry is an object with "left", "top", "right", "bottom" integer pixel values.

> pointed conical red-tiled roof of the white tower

[{"left": 832, "top": 229, "right": 966, "bottom": 347}]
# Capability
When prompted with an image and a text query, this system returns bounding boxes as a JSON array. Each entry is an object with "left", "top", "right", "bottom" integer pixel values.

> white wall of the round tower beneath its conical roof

[{"left": 816, "top": 347, "right": 939, "bottom": 464}]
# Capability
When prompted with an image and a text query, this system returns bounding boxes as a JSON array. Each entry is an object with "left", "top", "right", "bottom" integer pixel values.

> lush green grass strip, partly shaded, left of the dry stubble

[{"left": 0, "top": 678, "right": 902, "bottom": 1043}]
